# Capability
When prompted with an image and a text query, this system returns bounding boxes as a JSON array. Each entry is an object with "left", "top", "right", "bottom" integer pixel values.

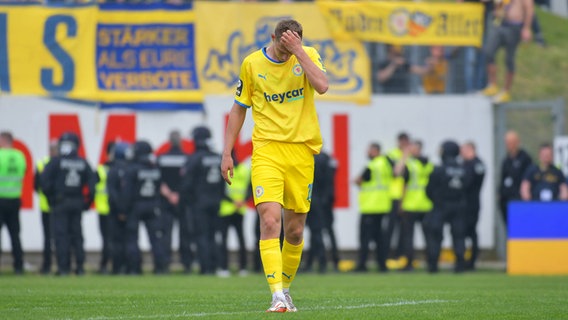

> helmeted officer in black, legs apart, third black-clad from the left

[{"left": 123, "top": 141, "right": 168, "bottom": 274}]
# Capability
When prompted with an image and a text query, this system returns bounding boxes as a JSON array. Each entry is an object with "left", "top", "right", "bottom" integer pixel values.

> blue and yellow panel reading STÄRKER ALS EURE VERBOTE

[{"left": 95, "top": 3, "right": 203, "bottom": 109}]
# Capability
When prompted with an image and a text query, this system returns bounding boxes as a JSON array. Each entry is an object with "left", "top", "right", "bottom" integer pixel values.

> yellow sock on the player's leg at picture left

[{"left": 259, "top": 238, "right": 282, "bottom": 293}]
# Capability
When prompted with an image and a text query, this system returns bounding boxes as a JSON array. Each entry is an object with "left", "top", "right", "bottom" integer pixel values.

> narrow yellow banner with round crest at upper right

[{"left": 317, "top": 1, "right": 484, "bottom": 47}]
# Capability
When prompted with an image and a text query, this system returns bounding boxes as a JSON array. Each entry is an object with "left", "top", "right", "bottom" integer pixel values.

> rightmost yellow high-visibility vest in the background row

[{"left": 402, "top": 158, "right": 434, "bottom": 213}]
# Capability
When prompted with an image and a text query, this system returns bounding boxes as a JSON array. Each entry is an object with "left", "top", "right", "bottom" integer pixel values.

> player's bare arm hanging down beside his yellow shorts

[{"left": 221, "top": 102, "right": 247, "bottom": 184}]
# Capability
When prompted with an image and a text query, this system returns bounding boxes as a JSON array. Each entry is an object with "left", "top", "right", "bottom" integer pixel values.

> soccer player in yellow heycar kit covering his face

[{"left": 221, "top": 20, "right": 328, "bottom": 312}]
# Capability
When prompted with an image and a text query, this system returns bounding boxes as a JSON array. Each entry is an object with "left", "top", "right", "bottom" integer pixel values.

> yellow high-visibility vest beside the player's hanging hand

[{"left": 219, "top": 163, "right": 250, "bottom": 217}]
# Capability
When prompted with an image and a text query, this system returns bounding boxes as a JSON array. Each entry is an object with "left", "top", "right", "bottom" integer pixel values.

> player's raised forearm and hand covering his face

[{"left": 280, "top": 30, "right": 329, "bottom": 94}]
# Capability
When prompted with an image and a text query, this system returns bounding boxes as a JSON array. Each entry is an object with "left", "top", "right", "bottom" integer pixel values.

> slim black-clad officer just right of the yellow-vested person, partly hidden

[{"left": 107, "top": 144, "right": 128, "bottom": 274}]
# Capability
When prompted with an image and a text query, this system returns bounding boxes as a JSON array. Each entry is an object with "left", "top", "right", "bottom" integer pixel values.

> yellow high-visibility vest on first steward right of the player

[{"left": 359, "top": 156, "right": 392, "bottom": 214}]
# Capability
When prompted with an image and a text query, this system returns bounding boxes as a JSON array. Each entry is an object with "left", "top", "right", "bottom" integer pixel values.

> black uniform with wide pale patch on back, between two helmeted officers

[{"left": 158, "top": 146, "right": 193, "bottom": 272}]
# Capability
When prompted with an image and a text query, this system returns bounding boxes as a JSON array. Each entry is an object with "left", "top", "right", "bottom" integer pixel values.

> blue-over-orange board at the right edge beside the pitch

[{"left": 507, "top": 202, "right": 568, "bottom": 275}]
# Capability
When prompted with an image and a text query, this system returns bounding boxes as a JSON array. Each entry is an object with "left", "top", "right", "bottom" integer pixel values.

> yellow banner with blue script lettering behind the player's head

[{"left": 194, "top": 1, "right": 371, "bottom": 103}]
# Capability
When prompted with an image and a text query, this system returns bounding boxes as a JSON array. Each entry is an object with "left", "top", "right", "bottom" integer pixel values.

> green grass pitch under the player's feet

[{"left": 0, "top": 271, "right": 568, "bottom": 320}]
